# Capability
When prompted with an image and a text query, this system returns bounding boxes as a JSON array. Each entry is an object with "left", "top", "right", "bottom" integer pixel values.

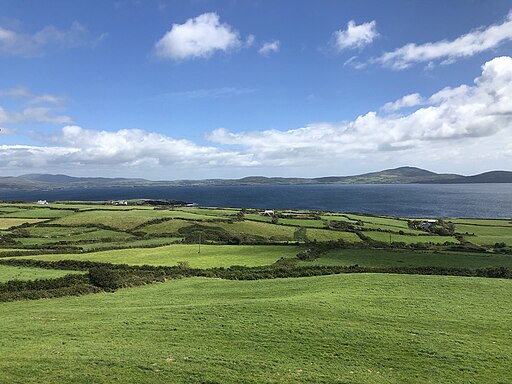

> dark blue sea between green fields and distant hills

[{"left": 0, "top": 184, "right": 512, "bottom": 218}]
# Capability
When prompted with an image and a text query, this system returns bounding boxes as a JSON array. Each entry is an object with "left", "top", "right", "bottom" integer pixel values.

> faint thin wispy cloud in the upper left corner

[{"left": 0, "top": 22, "right": 88, "bottom": 57}]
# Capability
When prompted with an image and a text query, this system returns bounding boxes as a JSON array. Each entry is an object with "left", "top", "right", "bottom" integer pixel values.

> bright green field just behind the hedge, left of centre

[{"left": 15, "top": 244, "right": 298, "bottom": 268}]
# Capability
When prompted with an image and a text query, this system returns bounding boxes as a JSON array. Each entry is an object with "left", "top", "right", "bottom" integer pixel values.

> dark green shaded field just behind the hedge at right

[{"left": 299, "top": 249, "right": 512, "bottom": 269}]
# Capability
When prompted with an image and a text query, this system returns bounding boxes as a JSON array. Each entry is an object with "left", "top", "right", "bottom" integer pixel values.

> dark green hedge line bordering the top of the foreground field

[{"left": 0, "top": 258, "right": 512, "bottom": 301}]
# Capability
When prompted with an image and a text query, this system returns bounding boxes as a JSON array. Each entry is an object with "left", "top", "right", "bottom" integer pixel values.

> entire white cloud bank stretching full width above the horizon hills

[{"left": 0, "top": 56, "right": 512, "bottom": 175}]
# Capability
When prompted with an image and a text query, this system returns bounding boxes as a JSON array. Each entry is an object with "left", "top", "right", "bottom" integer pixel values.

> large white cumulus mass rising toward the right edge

[{"left": 208, "top": 57, "right": 512, "bottom": 166}]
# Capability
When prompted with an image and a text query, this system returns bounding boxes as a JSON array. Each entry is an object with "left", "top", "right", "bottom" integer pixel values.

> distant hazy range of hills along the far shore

[{"left": 0, "top": 167, "right": 512, "bottom": 190}]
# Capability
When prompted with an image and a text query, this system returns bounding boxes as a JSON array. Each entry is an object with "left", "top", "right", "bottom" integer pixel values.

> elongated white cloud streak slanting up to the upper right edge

[{"left": 375, "top": 12, "right": 512, "bottom": 70}]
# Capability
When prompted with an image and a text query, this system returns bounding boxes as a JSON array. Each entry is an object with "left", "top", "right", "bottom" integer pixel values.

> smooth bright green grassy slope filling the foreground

[{"left": 0, "top": 274, "right": 512, "bottom": 384}]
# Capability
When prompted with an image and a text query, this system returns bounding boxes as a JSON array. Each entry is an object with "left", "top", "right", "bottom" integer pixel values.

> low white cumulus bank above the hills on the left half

[{"left": 0, "top": 126, "right": 253, "bottom": 168}]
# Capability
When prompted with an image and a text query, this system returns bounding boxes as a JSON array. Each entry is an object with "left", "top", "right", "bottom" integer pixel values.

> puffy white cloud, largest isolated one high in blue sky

[{"left": 155, "top": 13, "right": 244, "bottom": 60}]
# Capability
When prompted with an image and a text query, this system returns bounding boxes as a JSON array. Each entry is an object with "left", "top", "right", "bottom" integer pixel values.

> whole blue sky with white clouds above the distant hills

[{"left": 0, "top": 0, "right": 512, "bottom": 180}]
